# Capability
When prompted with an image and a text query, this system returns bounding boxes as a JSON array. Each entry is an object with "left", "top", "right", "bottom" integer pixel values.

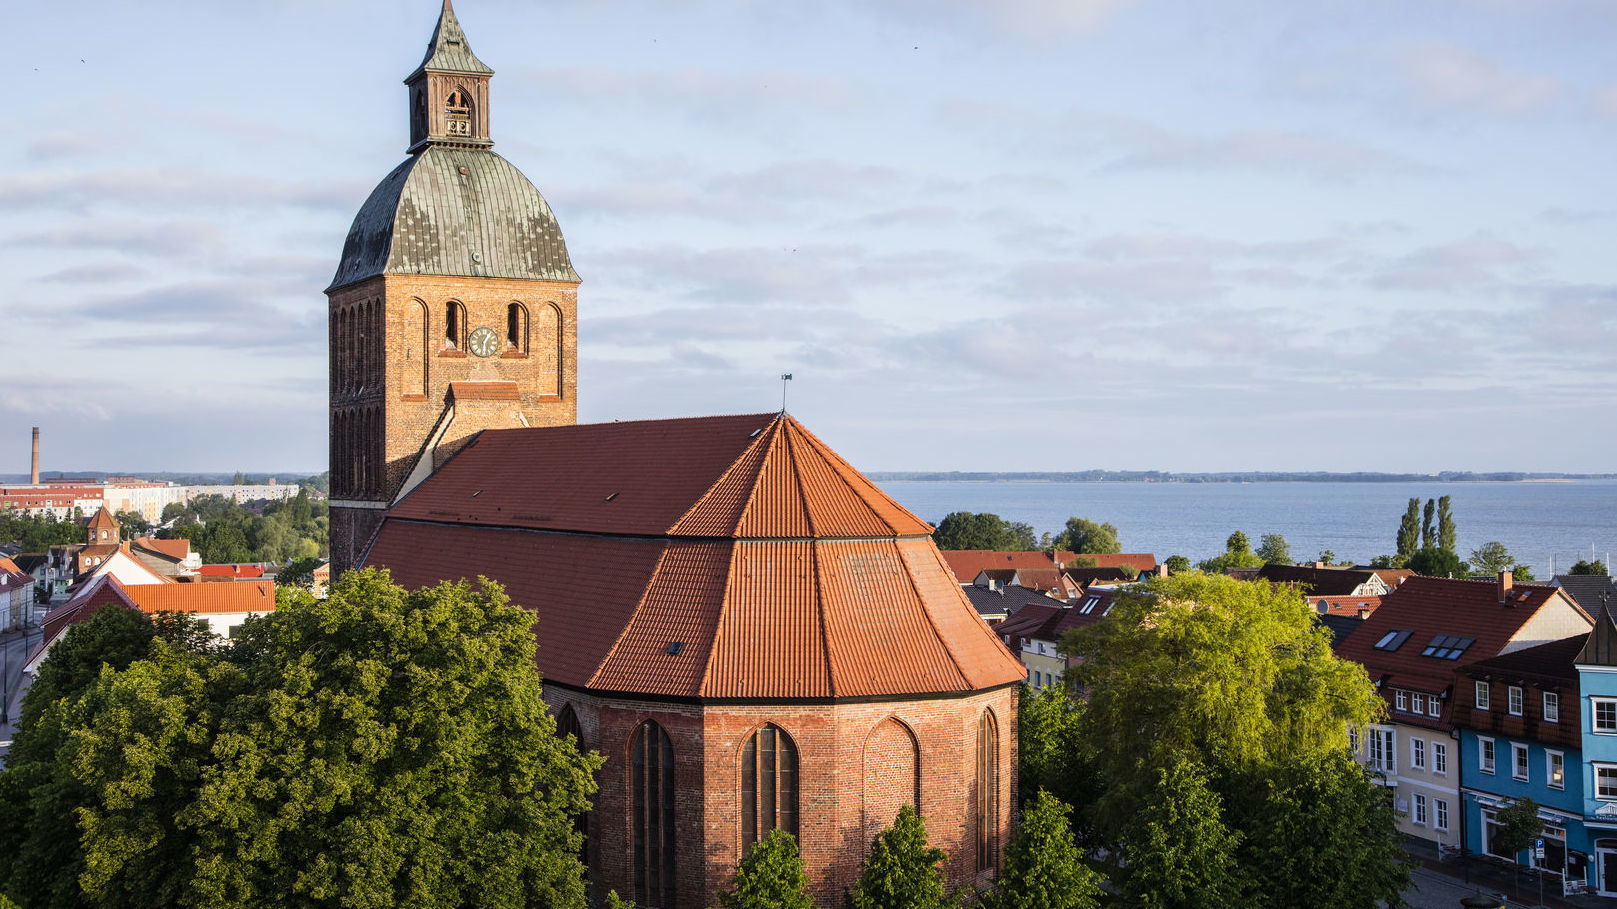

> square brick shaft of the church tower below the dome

[{"left": 330, "top": 268, "right": 579, "bottom": 573}]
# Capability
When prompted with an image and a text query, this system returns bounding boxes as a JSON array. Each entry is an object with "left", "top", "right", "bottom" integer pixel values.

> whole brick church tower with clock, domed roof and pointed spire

[{"left": 325, "top": 0, "right": 579, "bottom": 573}]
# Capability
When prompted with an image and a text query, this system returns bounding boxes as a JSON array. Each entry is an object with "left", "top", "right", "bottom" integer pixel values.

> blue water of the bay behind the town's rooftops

[{"left": 881, "top": 480, "right": 1617, "bottom": 577}]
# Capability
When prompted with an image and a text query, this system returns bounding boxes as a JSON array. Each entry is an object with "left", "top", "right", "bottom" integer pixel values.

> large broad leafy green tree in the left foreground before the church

[{"left": 20, "top": 569, "right": 598, "bottom": 907}]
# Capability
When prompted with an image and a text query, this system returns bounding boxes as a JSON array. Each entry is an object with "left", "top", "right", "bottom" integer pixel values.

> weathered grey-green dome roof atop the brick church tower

[{"left": 327, "top": 146, "right": 579, "bottom": 293}]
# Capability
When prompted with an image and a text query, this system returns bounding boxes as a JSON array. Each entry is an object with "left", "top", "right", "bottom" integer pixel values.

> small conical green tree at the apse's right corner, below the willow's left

[{"left": 978, "top": 791, "right": 1101, "bottom": 909}]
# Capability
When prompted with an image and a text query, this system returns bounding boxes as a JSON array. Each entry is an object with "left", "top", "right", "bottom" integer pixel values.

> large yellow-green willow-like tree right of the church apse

[{"left": 1062, "top": 574, "right": 1381, "bottom": 835}]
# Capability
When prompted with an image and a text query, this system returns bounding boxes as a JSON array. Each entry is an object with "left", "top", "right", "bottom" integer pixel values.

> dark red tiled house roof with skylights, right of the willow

[{"left": 1337, "top": 576, "right": 1588, "bottom": 721}]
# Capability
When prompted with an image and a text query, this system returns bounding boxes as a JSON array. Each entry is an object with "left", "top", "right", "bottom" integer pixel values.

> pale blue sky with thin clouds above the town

[{"left": 0, "top": 0, "right": 1617, "bottom": 472}]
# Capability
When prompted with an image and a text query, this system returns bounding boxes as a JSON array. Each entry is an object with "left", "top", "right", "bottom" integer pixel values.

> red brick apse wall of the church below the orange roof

[{"left": 545, "top": 686, "right": 1015, "bottom": 909}]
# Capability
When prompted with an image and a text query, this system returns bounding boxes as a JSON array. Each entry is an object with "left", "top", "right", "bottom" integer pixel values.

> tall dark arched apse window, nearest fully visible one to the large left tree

[{"left": 629, "top": 720, "right": 674, "bottom": 909}]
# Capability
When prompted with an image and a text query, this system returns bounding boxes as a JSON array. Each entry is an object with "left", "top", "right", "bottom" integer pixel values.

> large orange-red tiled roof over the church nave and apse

[{"left": 365, "top": 414, "right": 1025, "bottom": 700}]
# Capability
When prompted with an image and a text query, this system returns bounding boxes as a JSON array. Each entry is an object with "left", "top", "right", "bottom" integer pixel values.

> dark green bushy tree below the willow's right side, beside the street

[{"left": 1226, "top": 749, "right": 1410, "bottom": 909}]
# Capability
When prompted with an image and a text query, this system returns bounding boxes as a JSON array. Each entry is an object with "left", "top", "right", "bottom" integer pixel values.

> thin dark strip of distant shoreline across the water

[{"left": 867, "top": 471, "right": 1617, "bottom": 484}]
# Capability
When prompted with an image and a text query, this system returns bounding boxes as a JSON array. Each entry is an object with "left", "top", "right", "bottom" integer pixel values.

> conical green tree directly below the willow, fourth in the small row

[{"left": 1122, "top": 760, "right": 1242, "bottom": 909}]
